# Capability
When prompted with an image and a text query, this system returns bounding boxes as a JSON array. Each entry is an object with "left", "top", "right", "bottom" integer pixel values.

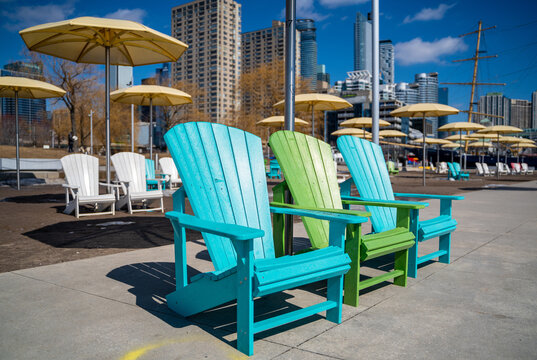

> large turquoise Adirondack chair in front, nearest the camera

[{"left": 164, "top": 122, "right": 367, "bottom": 355}]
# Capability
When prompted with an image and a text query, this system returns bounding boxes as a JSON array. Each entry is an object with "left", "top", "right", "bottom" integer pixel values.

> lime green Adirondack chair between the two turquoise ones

[{"left": 269, "top": 131, "right": 420, "bottom": 306}]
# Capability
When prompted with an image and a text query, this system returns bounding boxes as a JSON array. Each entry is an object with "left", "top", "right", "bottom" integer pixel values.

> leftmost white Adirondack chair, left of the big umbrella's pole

[{"left": 61, "top": 154, "right": 116, "bottom": 219}]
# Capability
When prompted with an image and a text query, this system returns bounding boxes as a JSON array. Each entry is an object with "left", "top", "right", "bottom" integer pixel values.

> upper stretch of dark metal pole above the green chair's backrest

[{"left": 285, "top": 0, "right": 296, "bottom": 131}]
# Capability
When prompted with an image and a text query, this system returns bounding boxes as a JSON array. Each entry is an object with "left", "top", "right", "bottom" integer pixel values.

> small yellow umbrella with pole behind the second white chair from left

[{"left": 110, "top": 85, "right": 192, "bottom": 159}]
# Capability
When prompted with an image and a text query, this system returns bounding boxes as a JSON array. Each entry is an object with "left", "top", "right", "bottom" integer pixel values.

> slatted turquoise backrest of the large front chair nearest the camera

[{"left": 164, "top": 122, "right": 274, "bottom": 270}]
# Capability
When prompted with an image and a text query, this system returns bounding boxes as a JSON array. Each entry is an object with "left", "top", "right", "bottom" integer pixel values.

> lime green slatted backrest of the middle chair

[{"left": 269, "top": 131, "right": 343, "bottom": 248}]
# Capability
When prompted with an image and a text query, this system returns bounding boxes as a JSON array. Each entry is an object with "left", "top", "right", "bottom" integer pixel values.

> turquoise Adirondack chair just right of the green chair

[{"left": 337, "top": 136, "right": 464, "bottom": 278}]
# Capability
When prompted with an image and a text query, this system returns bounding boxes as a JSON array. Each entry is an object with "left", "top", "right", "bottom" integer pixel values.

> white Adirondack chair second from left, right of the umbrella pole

[{"left": 110, "top": 152, "right": 164, "bottom": 214}]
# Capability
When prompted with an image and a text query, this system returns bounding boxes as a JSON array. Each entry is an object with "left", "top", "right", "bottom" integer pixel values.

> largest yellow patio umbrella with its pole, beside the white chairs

[{"left": 19, "top": 17, "right": 188, "bottom": 182}]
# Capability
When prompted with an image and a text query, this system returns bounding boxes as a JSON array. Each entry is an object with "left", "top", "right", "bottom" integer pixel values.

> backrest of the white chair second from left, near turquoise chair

[{"left": 110, "top": 152, "right": 147, "bottom": 192}]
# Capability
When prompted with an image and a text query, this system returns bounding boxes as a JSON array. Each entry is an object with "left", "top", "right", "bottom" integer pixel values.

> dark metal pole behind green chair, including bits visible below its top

[{"left": 284, "top": 0, "right": 296, "bottom": 255}]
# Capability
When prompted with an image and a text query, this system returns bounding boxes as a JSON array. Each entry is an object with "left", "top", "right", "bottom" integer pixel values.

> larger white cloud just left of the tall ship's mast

[{"left": 395, "top": 36, "right": 468, "bottom": 65}]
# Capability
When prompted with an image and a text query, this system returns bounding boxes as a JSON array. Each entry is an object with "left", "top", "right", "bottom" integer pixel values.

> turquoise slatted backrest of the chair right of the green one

[{"left": 337, "top": 135, "right": 396, "bottom": 232}]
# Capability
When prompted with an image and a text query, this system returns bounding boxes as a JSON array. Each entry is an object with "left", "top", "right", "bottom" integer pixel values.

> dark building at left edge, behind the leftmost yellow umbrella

[{"left": 0, "top": 61, "right": 47, "bottom": 144}]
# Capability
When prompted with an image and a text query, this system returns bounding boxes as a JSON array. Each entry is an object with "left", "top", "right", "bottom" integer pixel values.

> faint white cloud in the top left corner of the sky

[{"left": 1, "top": 1, "right": 75, "bottom": 31}]
